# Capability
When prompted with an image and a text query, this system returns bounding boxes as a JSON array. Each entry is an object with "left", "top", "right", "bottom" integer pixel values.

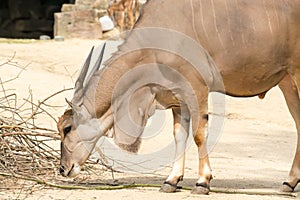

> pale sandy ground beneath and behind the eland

[{"left": 0, "top": 39, "right": 299, "bottom": 200}]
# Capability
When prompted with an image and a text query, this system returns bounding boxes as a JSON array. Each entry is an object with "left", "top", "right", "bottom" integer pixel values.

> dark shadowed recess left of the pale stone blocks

[{"left": 0, "top": 0, "right": 73, "bottom": 38}]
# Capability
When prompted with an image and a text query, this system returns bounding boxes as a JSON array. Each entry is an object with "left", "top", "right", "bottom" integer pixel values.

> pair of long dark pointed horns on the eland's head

[{"left": 71, "top": 43, "right": 106, "bottom": 106}]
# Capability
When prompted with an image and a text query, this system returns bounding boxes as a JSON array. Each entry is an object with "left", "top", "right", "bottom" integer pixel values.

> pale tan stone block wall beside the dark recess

[{"left": 54, "top": 0, "right": 109, "bottom": 39}]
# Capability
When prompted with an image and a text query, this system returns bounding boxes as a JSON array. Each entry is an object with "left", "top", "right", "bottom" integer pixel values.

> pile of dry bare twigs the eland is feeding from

[{"left": 0, "top": 56, "right": 111, "bottom": 193}]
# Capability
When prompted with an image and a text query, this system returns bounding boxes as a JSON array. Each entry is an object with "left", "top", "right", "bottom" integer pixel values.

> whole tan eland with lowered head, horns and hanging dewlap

[{"left": 57, "top": 0, "right": 300, "bottom": 194}]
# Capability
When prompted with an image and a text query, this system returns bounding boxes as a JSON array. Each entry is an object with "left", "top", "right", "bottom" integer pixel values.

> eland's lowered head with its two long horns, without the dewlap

[{"left": 57, "top": 44, "right": 105, "bottom": 176}]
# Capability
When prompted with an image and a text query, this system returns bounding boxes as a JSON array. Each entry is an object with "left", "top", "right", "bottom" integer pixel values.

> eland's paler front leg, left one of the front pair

[{"left": 160, "top": 108, "right": 190, "bottom": 193}]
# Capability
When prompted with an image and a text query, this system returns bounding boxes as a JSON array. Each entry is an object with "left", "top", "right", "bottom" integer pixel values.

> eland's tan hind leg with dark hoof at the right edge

[{"left": 279, "top": 75, "right": 300, "bottom": 192}]
